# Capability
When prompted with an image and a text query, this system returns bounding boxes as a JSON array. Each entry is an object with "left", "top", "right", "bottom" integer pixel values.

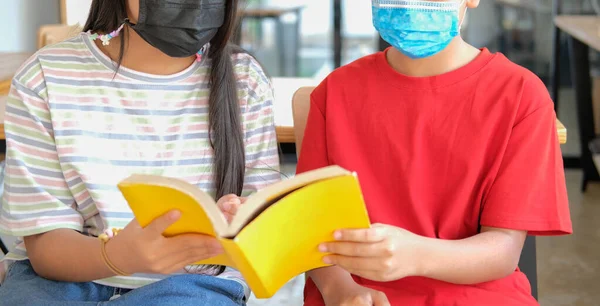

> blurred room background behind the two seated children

[{"left": 0, "top": 0, "right": 600, "bottom": 306}]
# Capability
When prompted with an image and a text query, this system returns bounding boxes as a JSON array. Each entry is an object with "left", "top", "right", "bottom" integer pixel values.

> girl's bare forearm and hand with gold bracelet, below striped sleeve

[{"left": 25, "top": 211, "right": 222, "bottom": 282}]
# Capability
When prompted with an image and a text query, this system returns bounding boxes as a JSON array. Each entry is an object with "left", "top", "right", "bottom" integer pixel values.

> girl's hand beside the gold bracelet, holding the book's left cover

[{"left": 104, "top": 211, "right": 223, "bottom": 274}]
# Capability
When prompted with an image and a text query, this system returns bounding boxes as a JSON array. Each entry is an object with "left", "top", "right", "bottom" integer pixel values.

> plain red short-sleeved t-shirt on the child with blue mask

[{"left": 298, "top": 49, "right": 572, "bottom": 306}]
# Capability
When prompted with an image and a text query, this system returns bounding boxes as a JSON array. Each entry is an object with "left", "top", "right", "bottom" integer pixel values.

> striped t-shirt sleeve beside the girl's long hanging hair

[{"left": 242, "top": 56, "right": 281, "bottom": 196}]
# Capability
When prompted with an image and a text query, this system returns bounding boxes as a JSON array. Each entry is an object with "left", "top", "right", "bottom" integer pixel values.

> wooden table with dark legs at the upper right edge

[{"left": 554, "top": 15, "right": 600, "bottom": 191}]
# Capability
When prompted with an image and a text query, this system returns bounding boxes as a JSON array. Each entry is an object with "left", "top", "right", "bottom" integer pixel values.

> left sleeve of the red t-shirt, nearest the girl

[{"left": 296, "top": 80, "right": 329, "bottom": 174}]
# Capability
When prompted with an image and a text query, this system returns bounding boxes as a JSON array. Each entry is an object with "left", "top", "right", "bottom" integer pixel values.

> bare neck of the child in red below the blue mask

[{"left": 387, "top": 37, "right": 480, "bottom": 77}]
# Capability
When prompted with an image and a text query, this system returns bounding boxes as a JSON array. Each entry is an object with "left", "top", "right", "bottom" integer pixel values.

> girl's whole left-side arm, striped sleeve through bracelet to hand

[{"left": 0, "top": 73, "right": 221, "bottom": 282}]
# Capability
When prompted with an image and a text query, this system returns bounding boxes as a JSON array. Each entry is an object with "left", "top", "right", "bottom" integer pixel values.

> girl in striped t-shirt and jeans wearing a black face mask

[{"left": 0, "top": 0, "right": 279, "bottom": 305}]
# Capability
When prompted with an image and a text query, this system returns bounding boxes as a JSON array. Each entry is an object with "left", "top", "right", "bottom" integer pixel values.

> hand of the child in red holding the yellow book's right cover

[{"left": 319, "top": 224, "right": 423, "bottom": 282}]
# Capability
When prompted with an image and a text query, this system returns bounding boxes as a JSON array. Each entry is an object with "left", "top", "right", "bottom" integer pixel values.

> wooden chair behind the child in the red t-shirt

[{"left": 292, "top": 87, "right": 567, "bottom": 299}]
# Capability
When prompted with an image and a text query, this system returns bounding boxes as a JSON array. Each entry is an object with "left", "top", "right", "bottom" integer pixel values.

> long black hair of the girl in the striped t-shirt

[{"left": 83, "top": 0, "right": 246, "bottom": 272}]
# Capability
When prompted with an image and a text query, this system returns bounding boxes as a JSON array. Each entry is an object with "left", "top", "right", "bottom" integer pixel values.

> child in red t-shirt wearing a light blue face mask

[{"left": 298, "top": 0, "right": 572, "bottom": 306}]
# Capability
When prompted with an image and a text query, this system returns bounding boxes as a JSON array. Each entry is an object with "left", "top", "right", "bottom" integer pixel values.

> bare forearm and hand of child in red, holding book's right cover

[{"left": 321, "top": 224, "right": 527, "bottom": 285}]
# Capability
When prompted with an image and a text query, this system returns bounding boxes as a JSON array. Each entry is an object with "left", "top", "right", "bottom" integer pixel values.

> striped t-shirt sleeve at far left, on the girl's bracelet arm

[{"left": 0, "top": 63, "right": 83, "bottom": 237}]
